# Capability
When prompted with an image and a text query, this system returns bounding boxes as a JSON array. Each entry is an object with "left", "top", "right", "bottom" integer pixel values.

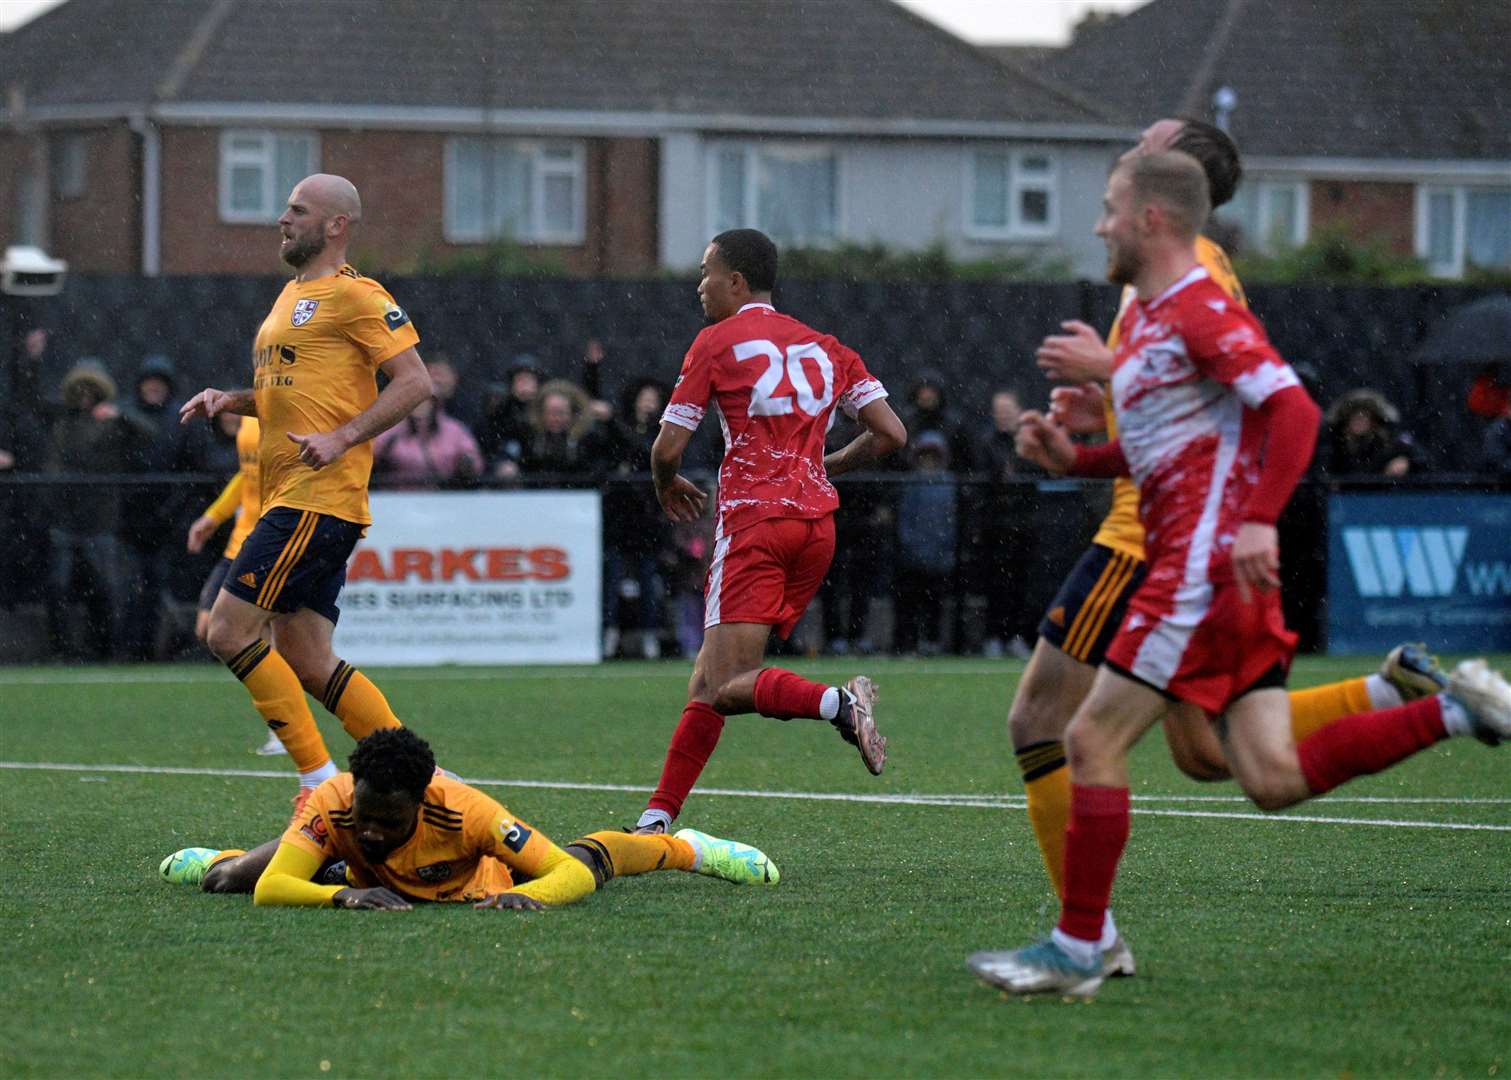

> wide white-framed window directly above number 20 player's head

[{"left": 709, "top": 143, "right": 840, "bottom": 245}]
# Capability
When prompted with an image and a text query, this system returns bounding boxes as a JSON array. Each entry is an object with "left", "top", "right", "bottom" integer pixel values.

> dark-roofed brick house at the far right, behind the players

[{"left": 1018, "top": 0, "right": 1511, "bottom": 276}]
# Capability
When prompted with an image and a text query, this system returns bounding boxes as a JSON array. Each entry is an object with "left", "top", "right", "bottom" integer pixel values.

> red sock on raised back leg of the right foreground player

[{"left": 1296, "top": 696, "right": 1448, "bottom": 795}]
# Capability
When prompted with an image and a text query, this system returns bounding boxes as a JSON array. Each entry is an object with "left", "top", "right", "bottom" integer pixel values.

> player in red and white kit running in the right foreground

[{"left": 967, "top": 151, "right": 1511, "bottom": 997}]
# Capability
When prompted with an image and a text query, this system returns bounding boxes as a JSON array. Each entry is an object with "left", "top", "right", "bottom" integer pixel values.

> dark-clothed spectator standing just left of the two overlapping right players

[{"left": 972, "top": 388, "right": 1044, "bottom": 659}]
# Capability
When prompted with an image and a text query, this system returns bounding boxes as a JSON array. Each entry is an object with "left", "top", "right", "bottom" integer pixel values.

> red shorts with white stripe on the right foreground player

[{"left": 1108, "top": 582, "right": 1296, "bottom": 714}]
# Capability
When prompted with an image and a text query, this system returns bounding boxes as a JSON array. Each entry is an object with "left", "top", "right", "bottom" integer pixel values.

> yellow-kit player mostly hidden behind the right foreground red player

[{"left": 1008, "top": 118, "right": 1446, "bottom": 976}]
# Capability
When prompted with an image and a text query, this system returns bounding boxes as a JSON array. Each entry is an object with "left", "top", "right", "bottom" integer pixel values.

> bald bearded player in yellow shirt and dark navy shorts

[{"left": 181, "top": 174, "right": 431, "bottom": 813}]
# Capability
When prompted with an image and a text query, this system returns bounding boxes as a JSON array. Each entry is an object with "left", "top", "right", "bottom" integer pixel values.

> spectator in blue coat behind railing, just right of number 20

[{"left": 893, "top": 429, "right": 956, "bottom": 656}]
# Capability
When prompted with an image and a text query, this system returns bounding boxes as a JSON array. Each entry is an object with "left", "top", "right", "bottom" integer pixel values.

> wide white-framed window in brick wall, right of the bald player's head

[{"left": 446, "top": 137, "right": 586, "bottom": 245}]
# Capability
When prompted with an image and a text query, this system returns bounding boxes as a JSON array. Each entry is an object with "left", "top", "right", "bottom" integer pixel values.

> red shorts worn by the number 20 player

[{"left": 703, "top": 515, "right": 834, "bottom": 637}]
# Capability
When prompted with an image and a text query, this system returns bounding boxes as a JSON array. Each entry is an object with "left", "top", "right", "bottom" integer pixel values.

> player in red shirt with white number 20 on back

[{"left": 636, "top": 228, "right": 908, "bottom": 832}]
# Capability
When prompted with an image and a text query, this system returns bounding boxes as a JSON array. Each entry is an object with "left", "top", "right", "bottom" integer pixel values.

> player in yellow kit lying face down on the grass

[{"left": 159, "top": 728, "right": 780, "bottom": 911}]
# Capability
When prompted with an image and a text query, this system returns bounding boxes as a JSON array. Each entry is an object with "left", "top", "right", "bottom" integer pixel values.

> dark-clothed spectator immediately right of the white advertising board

[{"left": 603, "top": 378, "right": 671, "bottom": 659}]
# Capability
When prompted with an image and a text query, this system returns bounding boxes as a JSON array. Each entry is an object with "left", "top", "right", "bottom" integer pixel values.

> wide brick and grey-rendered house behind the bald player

[{"left": 0, "top": 0, "right": 1132, "bottom": 275}]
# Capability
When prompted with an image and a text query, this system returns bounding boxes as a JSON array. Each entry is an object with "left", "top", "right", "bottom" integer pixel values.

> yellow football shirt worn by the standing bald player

[{"left": 252, "top": 266, "right": 420, "bottom": 526}]
